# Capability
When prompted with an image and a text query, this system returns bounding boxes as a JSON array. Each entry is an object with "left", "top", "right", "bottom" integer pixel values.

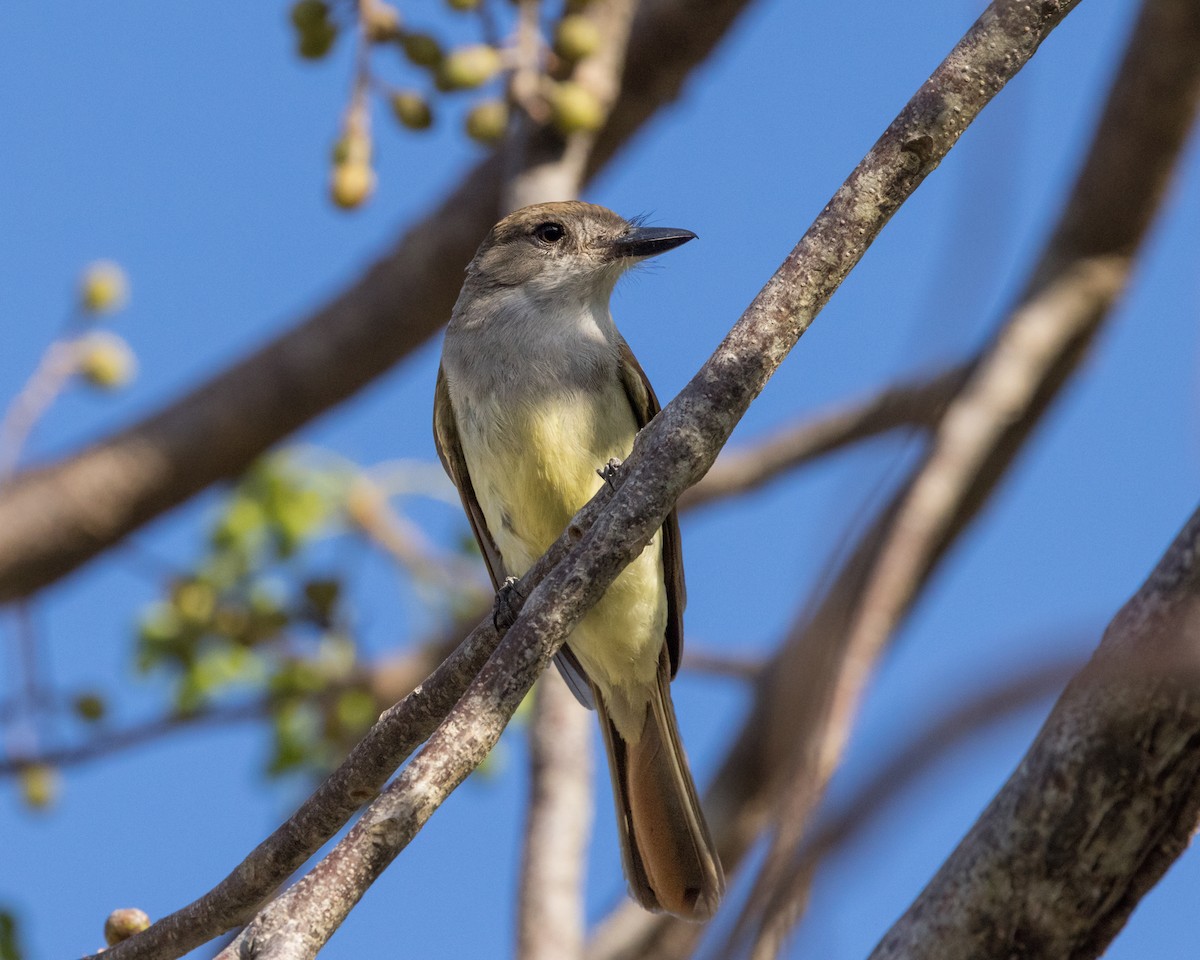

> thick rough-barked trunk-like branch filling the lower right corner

[{"left": 871, "top": 511, "right": 1200, "bottom": 960}]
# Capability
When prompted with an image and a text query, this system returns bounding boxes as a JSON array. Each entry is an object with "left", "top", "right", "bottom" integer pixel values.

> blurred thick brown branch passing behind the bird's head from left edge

[{"left": 0, "top": 0, "right": 749, "bottom": 602}]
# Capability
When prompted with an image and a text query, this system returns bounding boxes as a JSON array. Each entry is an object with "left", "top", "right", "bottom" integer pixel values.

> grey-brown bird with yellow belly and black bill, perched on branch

[{"left": 433, "top": 202, "right": 725, "bottom": 919}]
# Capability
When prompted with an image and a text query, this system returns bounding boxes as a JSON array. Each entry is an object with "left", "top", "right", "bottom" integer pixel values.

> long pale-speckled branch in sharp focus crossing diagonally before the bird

[{"left": 199, "top": 0, "right": 1076, "bottom": 958}]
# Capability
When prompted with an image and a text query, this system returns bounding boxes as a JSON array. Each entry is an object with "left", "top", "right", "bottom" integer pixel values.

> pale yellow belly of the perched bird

[{"left": 463, "top": 383, "right": 667, "bottom": 733}]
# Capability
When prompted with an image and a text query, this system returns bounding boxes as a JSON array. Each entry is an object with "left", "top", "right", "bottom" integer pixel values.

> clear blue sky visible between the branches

[{"left": 0, "top": 0, "right": 1200, "bottom": 959}]
